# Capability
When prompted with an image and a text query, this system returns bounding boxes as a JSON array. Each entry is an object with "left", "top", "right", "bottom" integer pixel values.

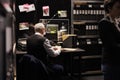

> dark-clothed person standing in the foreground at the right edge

[{"left": 99, "top": 0, "right": 120, "bottom": 80}]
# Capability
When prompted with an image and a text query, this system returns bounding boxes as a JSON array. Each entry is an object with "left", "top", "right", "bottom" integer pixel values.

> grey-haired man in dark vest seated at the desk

[{"left": 27, "top": 23, "right": 63, "bottom": 78}]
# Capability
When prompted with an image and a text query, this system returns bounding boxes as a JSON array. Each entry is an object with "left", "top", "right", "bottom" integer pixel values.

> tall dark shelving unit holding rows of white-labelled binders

[{"left": 71, "top": 0, "right": 105, "bottom": 75}]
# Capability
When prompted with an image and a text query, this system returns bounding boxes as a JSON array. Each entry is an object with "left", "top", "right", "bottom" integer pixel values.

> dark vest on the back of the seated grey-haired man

[{"left": 27, "top": 34, "right": 47, "bottom": 64}]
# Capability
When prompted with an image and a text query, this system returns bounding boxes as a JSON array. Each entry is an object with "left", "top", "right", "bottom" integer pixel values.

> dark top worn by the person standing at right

[{"left": 99, "top": 16, "right": 120, "bottom": 65}]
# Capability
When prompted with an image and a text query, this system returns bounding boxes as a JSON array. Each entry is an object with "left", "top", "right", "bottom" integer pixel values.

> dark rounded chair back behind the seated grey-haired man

[{"left": 17, "top": 54, "right": 50, "bottom": 80}]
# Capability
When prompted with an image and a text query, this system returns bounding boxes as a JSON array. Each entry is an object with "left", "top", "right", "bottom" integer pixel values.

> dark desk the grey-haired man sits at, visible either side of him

[{"left": 16, "top": 48, "right": 85, "bottom": 76}]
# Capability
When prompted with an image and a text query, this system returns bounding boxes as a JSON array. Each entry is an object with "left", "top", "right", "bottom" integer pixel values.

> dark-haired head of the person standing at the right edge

[{"left": 104, "top": 0, "right": 120, "bottom": 17}]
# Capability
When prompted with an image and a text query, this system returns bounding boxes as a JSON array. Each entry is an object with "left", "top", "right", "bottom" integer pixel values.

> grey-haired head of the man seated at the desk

[{"left": 34, "top": 23, "right": 46, "bottom": 35}]
